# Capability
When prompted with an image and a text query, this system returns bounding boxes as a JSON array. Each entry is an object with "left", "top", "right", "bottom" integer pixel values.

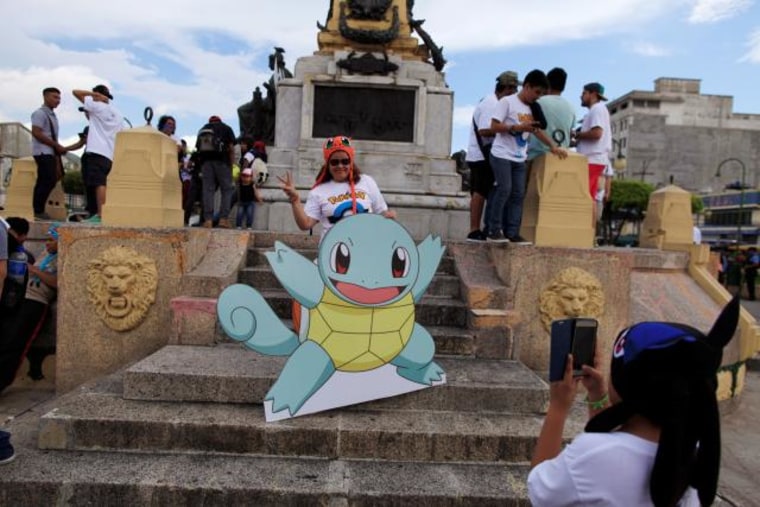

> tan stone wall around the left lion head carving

[{"left": 56, "top": 224, "right": 248, "bottom": 392}]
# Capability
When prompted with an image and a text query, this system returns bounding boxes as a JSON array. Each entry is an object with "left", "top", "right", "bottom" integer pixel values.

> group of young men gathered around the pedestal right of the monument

[{"left": 466, "top": 67, "right": 613, "bottom": 244}]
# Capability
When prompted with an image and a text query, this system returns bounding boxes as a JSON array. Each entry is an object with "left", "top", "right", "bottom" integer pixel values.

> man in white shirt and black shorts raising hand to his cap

[{"left": 73, "top": 85, "right": 124, "bottom": 223}]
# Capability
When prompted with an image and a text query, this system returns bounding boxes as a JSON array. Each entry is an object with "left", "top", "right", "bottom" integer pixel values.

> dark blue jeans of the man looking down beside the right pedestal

[{"left": 488, "top": 154, "right": 527, "bottom": 238}]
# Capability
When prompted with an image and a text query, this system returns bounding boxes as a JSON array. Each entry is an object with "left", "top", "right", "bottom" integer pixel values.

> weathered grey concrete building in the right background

[{"left": 608, "top": 77, "right": 760, "bottom": 193}]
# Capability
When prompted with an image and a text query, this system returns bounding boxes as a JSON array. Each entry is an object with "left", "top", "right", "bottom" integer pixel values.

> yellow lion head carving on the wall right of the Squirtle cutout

[{"left": 538, "top": 268, "right": 604, "bottom": 332}]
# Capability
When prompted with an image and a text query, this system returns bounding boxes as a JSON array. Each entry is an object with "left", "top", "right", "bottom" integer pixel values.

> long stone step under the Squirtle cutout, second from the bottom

[{"left": 39, "top": 391, "right": 543, "bottom": 463}]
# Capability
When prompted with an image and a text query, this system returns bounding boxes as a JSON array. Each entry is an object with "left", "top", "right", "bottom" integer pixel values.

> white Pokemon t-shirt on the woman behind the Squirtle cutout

[{"left": 304, "top": 174, "right": 388, "bottom": 241}]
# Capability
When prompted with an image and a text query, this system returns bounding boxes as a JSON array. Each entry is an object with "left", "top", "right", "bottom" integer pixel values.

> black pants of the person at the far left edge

[{"left": 0, "top": 299, "right": 50, "bottom": 391}]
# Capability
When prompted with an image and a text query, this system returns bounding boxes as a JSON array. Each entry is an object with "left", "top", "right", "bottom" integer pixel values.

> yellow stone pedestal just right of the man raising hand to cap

[{"left": 101, "top": 127, "right": 184, "bottom": 227}]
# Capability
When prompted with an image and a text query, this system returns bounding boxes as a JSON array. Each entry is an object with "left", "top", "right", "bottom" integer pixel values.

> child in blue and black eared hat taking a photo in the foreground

[{"left": 528, "top": 297, "right": 739, "bottom": 507}]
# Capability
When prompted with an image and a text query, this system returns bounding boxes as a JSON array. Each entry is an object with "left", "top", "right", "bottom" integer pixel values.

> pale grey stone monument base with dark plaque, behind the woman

[{"left": 266, "top": 51, "right": 469, "bottom": 239}]
